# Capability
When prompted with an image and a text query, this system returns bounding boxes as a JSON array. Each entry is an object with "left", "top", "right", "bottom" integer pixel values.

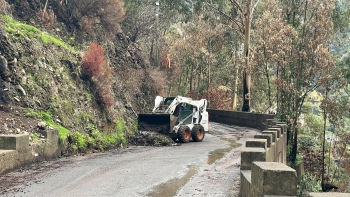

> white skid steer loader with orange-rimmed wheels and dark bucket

[{"left": 138, "top": 96, "right": 209, "bottom": 143}]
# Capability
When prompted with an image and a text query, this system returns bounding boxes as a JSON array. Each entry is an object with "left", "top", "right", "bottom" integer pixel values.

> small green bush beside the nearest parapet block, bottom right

[{"left": 298, "top": 173, "right": 322, "bottom": 197}]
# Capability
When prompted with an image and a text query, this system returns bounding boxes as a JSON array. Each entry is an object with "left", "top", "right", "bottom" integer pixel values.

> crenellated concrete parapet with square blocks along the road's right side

[{"left": 240, "top": 124, "right": 298, "bottom": 197}]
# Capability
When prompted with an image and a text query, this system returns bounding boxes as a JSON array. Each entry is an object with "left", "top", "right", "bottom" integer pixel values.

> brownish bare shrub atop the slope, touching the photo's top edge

[{"left": 52, "top": 0, "right": 125, "bottom": 39}]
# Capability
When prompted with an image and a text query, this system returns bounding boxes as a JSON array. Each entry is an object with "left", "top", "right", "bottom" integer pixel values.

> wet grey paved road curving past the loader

[{"left": 0, "top": 123, "right": 258, "bottom": 197}]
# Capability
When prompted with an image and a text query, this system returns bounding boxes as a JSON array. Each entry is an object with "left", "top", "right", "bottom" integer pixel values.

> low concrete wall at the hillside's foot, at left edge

[{"left": 0, "top": 129, "right": 61, "bottom": 174}]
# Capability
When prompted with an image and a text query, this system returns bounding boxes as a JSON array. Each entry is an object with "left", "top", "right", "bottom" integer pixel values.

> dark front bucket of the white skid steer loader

[{"left": 138, "top": 114, "right": 171, "bottom": 135}]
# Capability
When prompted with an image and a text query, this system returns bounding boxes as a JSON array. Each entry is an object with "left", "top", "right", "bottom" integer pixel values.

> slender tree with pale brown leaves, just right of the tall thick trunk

[{"left": 251, "top": 1, "right": 297, "bottom": 114}]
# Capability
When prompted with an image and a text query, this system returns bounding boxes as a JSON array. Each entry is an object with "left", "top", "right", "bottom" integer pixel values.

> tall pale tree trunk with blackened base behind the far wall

[{"left": 242, "top": 0, "right": 252, "bottom": 112}]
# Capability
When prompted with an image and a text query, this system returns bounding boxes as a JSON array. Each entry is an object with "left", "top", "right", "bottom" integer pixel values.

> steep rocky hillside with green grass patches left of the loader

[{"left": 0, "top": 13, "right": 162, "bottom": 151}]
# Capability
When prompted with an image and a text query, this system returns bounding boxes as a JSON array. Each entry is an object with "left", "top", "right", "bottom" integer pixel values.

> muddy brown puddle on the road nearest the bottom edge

[{"left": 146, "top": 165, "right": 199, "bottom": 197}]
